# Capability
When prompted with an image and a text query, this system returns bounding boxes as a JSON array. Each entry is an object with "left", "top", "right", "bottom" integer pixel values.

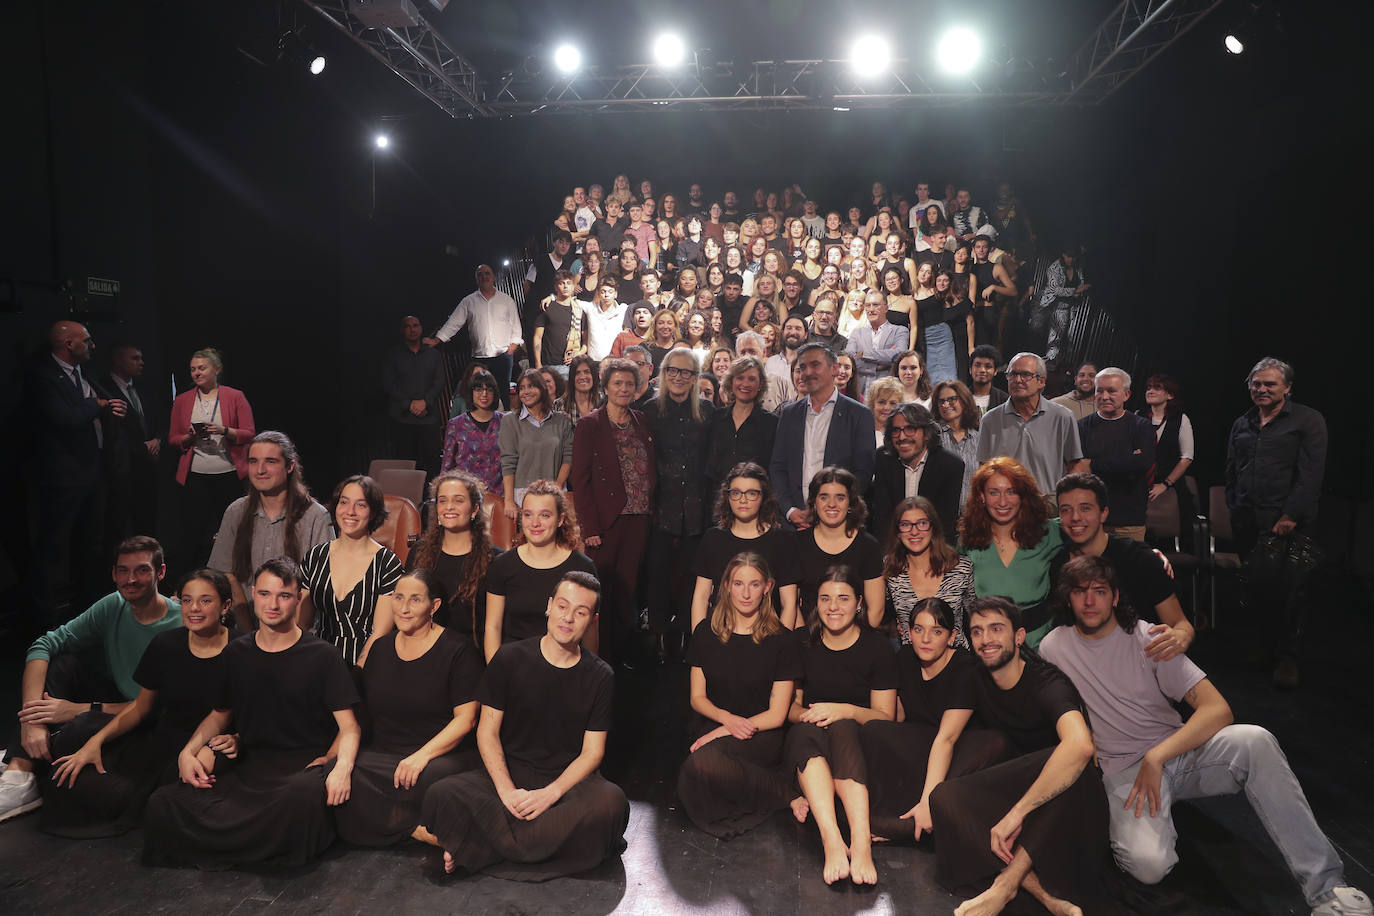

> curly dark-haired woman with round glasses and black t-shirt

[{"left": 691, "top": 461, "right": 801, "bottom": 630}]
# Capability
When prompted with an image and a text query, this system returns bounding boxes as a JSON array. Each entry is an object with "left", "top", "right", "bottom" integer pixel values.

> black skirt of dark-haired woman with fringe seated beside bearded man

[{"left": 861, "top": 720, "right": 1010, "bottom": 842}]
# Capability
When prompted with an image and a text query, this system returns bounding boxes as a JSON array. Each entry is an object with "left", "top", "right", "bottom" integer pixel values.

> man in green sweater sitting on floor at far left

[{"left": 0, "top": 537, "right": 181, "bottom": 821}]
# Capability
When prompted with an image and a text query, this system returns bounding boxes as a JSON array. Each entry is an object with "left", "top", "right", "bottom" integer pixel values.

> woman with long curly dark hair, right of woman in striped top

[{"left": 407, "top": 471, "right": 502, "bottom": 647}]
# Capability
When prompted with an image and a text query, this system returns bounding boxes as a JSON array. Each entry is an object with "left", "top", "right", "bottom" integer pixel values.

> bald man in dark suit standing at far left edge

[{"left": 27, "top": 321, "right": 128, "bottom": 629}]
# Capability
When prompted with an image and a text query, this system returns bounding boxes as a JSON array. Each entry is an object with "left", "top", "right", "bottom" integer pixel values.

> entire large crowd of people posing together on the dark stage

[{"left": 8, "top": 176, "right": 1371, "bottom": 915}]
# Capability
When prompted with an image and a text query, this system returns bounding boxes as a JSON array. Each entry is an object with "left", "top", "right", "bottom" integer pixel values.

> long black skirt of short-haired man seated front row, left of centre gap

[{"left": 420, "top": 770, "right": 629, "bottom": 882}]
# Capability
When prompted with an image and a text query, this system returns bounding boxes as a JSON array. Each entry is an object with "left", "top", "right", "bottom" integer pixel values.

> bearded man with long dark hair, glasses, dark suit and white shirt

[{"left": 868, "top": 404, "right": 963, "bottom": 541}]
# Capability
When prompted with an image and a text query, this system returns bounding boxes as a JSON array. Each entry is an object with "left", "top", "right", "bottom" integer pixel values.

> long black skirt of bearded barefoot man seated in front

[{"left": 930, "top": 748, "right": 1107, "bottom": 912}]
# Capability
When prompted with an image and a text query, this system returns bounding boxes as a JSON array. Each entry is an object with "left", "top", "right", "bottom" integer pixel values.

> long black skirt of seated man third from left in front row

[{"left": 143, "top": 750, "right": 334, "bottom": 869}]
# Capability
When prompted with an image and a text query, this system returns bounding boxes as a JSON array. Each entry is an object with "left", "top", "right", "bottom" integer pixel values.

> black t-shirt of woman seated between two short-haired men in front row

[{"left": 363, "top": 629, "right": 482, "bottom": 755}]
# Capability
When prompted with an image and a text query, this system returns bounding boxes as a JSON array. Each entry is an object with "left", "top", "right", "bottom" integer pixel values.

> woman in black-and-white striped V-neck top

[{"left": 300, "top": 474, "right": 401, "bottom": 666}]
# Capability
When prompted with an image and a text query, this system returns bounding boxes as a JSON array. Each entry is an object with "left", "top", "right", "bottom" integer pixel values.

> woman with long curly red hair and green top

[{"left": 959, "top": 457, "right": 1063, "bottom": 648}]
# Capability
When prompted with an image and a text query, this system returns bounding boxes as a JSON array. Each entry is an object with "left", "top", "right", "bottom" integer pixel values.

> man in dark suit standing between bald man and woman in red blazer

[{"left": 100, "top": 343, "right": 162, "bottom": 543}]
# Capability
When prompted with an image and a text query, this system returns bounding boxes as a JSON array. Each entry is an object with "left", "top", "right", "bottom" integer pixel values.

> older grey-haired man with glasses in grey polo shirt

[{"left": 978, "top": 353, "right": 1087, "bottom": 496}]
